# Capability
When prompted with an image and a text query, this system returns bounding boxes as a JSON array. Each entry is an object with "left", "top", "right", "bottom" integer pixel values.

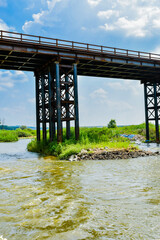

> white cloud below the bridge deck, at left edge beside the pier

[{"left": 0, "top": 71, "right": 28, "bottom": 91}]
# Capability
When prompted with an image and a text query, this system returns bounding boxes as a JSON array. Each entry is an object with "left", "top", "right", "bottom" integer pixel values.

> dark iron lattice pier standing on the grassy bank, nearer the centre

[{"left": 35, "top": 62, "right": 79, "bottom": 142}]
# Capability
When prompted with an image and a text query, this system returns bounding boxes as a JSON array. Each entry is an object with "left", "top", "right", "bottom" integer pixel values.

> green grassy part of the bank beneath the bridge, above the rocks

[{"left": 27, "top": 124, "right": 158, "bottom": 159}]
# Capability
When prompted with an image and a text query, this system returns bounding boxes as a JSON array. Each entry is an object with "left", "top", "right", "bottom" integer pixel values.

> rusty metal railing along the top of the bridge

[{"left": 0, "top": 30, "right": 160, "bottom": 60}]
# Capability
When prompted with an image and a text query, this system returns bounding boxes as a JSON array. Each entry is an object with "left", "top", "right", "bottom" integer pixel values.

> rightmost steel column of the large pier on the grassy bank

[{"left": 73, "top": 64, "right": 79, "bottom": 140}]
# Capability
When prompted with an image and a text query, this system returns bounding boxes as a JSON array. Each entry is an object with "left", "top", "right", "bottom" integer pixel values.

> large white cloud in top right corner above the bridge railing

[{"left": 97, "top": 0, "right": 160, "bottom": 38}]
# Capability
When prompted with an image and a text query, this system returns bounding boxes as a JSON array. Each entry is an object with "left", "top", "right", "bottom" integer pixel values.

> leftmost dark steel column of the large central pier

[{"left": 35, "top": 73, "right": 41, "bottom": 141}]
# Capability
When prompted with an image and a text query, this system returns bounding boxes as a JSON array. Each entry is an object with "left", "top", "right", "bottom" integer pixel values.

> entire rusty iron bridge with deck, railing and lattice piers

[{"left": 0, "top": 31, "right": 160, "bottom": 142}]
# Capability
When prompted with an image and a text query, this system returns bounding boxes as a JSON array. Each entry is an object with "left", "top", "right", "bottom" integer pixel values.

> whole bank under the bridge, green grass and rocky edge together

[{"left": 27, "top": 124, "right": 159, "bottom": 161}]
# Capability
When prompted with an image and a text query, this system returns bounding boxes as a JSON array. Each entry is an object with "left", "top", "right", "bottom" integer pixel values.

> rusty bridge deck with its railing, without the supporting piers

[{"left": 0, "top": 31, "right": 160, "bottom": 81}]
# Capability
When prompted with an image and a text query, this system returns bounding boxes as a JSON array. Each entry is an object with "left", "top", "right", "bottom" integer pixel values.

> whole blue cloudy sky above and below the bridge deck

[{"left": 0, "top": 0, "right": 160, "bottom": 126}]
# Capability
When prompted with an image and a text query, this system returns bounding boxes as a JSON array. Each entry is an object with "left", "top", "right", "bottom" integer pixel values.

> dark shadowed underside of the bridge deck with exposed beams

[{"left": 0, "top": 49, "right": 160, "bottom": 81}]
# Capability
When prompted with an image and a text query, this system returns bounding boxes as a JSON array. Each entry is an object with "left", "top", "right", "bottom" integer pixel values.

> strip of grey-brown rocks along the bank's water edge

[{"left": 69, "top": 149, "right": 160, "bottom": 161}]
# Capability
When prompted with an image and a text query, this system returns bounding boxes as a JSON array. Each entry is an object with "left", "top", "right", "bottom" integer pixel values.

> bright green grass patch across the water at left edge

[{"left": 0, "top": 128, "right": 36, "bottom": 142}]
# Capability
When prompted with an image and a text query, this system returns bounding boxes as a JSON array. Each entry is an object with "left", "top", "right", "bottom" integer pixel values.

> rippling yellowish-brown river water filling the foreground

[{"left": 0, "top": 140, "right": 160, "bottom": 240}]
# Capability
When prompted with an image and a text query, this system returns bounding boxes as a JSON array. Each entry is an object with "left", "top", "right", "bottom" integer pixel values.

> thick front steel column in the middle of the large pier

[{"left": 55, "top": 62, "right": 62, "bottom": 142}]
